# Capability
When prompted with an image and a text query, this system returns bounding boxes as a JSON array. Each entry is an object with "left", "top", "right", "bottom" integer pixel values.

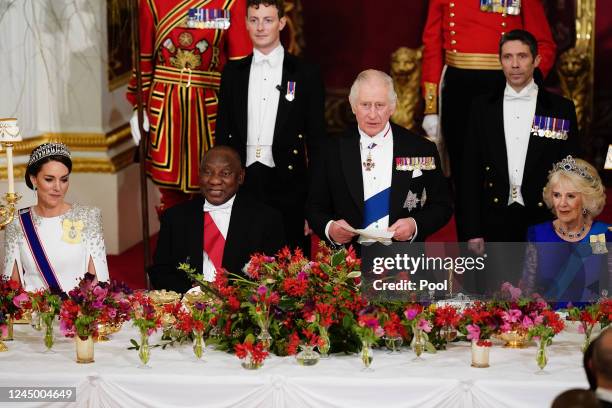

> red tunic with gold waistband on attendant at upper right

[{"left": 421, "top": 0, "right": 556, "bottom": 114}]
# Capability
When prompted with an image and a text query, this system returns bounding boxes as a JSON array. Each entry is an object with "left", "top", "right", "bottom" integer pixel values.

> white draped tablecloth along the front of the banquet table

[{"left": 0, "top": 323, "right": 588, "bottom": 408}]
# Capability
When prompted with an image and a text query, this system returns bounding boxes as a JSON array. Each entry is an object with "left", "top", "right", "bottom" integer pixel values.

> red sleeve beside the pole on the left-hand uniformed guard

[{"left": 126, "top": 0, "right": 155, "bottom": 107}]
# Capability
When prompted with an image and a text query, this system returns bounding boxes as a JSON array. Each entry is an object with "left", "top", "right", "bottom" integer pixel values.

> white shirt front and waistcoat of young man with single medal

[{"left": 246, "top": 45, "right": 285, "bottom": 167}]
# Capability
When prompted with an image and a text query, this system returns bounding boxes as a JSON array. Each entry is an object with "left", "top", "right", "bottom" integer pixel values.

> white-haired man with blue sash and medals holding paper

[{"left": 307, "top": 70, "right": 452, "bottom": 244}]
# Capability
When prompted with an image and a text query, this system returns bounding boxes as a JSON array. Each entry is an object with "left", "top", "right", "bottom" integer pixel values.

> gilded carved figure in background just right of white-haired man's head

[{"left": 391, "top": 47, "right": 423, "bottom": 129}]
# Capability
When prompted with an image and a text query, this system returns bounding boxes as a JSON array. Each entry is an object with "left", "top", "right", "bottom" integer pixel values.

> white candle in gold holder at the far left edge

[{"left": 0, "top": 118, "right": 21, "bottom": 229}]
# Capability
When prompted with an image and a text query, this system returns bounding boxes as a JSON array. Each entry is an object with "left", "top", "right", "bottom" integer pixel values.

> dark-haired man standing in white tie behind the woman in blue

[{"left": 458, "top": 30, "right": 578, "bottom": 249}]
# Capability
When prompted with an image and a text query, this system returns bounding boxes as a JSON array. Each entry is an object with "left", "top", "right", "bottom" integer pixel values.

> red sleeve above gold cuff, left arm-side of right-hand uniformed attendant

[{"left": 421, "top": 0, "right": 444, "bottom": 92}]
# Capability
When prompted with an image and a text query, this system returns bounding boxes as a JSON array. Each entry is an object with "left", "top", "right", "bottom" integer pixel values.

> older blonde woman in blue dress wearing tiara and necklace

[{"left": 523, "top": 156, "right": 612, "bottom": 305}]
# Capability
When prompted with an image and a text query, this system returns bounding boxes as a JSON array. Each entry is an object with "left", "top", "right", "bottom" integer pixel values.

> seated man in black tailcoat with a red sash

[{"left": 148, "top": 146, "right": 285, "bottom": 292}]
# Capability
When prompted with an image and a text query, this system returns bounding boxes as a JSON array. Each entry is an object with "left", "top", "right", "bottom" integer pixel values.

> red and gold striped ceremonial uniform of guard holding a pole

[{"left": 127, "top": 0, "right": 252, "bottom": 198}]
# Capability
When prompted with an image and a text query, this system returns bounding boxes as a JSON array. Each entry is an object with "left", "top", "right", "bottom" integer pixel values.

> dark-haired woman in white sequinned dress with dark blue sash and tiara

[{"left": 4, "top": 143, "right": 108, "bottom": 293}]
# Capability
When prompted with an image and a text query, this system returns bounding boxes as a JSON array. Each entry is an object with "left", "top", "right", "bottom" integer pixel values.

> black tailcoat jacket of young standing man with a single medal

[{"left": 215, "top": 52, "right": 325, "bottom": 183}]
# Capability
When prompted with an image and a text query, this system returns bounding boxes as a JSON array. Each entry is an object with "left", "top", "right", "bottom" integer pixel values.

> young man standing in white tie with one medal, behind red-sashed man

[{"left": 215, "top": 0, "right": 325, "bottom": 252}]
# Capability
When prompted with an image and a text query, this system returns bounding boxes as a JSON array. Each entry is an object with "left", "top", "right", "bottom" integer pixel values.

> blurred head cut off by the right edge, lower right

[{"left": 593, "top": 327, "right": 612, "bottom": 408}]
